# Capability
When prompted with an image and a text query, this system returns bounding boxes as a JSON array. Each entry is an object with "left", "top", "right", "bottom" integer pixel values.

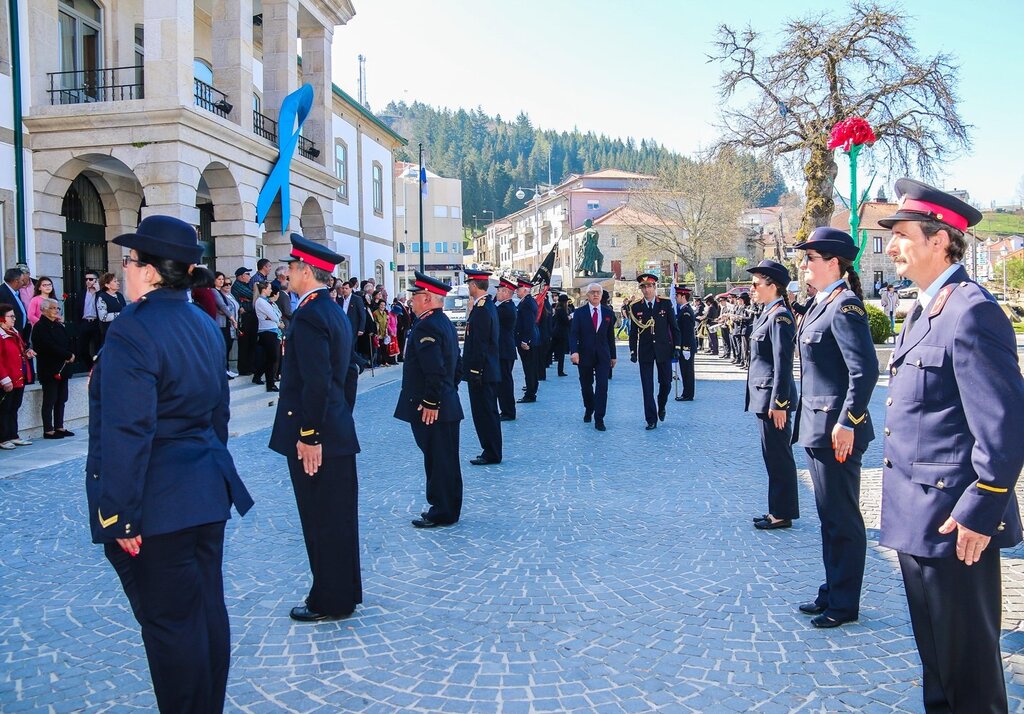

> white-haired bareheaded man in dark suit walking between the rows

[{"left": 569, "top": 283, "right": 615, "bottom": 431}]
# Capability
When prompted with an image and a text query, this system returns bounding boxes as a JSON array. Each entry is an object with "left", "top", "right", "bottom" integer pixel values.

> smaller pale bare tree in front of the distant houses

[{"left": 627, "top": 149, "right": 750, "bottom": 294}]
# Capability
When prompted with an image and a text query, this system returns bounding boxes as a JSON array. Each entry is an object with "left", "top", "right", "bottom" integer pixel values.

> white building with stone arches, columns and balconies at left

[{"left": 0, "top": 0, "right": 404, "bottom": 317}]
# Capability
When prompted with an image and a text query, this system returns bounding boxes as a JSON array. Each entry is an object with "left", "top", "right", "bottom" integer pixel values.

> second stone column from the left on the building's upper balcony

[{"left": 213, "top": 0, "right": 253, "bottom": 125}]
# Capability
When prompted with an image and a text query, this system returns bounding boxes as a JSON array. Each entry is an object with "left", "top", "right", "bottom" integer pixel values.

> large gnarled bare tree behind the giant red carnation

[{"left": 710, "top": 1, "right": 970, "bottom": 237}]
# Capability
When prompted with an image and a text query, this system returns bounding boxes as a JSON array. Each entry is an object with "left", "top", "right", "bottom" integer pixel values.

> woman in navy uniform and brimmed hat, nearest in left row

[{"left": 86, "top": 216, "right": 253, "bottom": 712}]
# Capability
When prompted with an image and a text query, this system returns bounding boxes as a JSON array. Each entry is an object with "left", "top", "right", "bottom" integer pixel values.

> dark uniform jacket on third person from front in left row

[{"left": 394, "top": 308, "right": 463, "bottom": 423}]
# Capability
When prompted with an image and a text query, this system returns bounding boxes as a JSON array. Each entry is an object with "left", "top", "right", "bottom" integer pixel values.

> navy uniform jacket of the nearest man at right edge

[{"left": 880, "top": 267, "right": 1024, "bottom": 557}]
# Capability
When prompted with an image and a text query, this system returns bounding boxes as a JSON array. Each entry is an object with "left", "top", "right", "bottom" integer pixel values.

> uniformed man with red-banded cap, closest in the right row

[{"left": 879, "top": 178, "right": 1024, "bottom": 712}]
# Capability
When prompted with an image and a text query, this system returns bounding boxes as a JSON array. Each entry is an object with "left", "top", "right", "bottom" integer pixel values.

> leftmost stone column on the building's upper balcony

[{"left": 142, "top": 0, "right": 196, "bottom": 107}]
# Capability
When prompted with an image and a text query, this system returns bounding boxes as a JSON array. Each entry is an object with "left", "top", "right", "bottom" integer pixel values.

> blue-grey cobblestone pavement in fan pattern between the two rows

[{"left": 0, "top": 346, "right": 1024, "bottom": 712}]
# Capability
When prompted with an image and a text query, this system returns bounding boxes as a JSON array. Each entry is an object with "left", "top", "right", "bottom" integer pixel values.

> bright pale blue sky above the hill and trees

[{"left": 334, "top": 0, "right": 1024, "bottom": 207}]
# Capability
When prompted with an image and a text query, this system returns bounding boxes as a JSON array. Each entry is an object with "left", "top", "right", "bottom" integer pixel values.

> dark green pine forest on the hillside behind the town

[{"left": 380, "top": 101, "right": 785, "bottom": 226}]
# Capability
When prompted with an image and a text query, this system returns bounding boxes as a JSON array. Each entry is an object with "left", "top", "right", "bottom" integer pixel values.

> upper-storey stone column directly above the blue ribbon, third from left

[{"left": 263, "top": 0, "right": 299, "bottom": 120}]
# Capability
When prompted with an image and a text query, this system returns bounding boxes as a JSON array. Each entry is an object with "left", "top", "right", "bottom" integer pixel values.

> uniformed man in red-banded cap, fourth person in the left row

[{"left": 462, "top": 269, "right": 502, "bottom": 466}]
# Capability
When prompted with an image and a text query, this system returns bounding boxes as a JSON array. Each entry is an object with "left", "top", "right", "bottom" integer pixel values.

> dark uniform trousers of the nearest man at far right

[{"left": 899, "top": 545, "right": 1007, "bottom": 714}]
